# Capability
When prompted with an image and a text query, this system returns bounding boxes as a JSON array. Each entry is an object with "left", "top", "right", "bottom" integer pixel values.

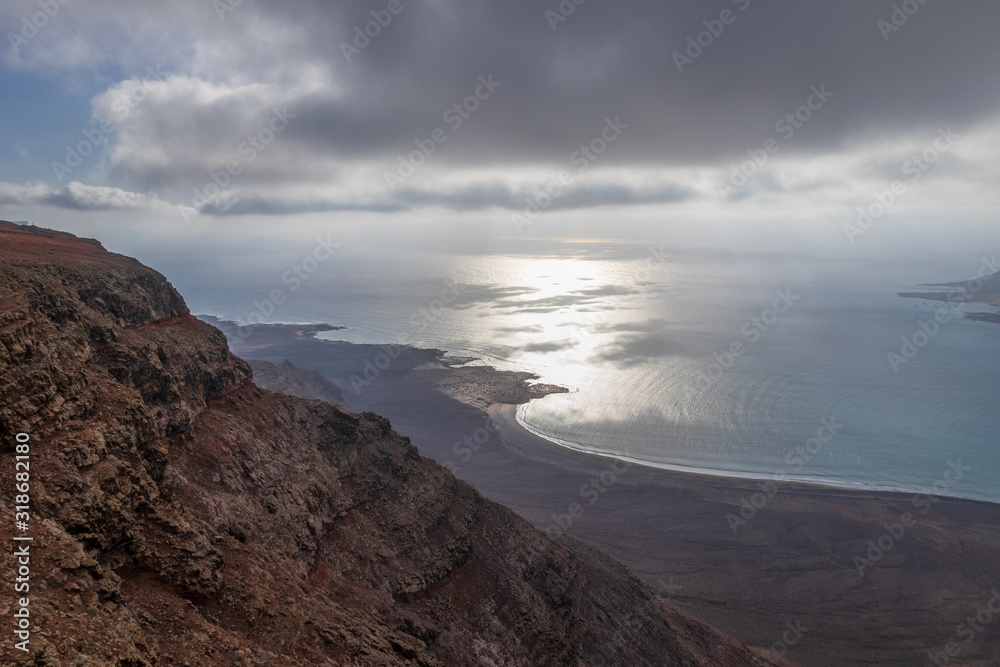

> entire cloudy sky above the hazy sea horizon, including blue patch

[{"left": 0, "top": 0, "right": 1000, "bottom": 255}]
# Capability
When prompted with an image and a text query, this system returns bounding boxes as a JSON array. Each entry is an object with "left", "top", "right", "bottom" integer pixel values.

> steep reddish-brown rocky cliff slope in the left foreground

[{"left": 0, "top": 223, "right": 770, "bottom": 667}]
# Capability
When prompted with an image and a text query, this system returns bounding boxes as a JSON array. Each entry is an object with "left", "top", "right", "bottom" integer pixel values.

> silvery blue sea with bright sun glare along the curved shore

[{"left": 144, "top": 240, "right": 1000, "bottom": 502}]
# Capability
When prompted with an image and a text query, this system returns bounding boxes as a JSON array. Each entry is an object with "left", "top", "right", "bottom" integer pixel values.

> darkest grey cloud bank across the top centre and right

[{"left": 261, "top": 0, "right": 1000, "bottom": 164}]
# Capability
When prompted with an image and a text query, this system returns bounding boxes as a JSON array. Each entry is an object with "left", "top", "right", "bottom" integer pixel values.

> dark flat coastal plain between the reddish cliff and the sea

[{"left": 214, "top": 322, "right": 1000, "bottom": 666}]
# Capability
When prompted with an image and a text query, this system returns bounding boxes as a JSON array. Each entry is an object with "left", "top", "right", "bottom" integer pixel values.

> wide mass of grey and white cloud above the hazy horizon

[{"left": 0, "top": 0, "right": 1000, "bottom": 216}]
